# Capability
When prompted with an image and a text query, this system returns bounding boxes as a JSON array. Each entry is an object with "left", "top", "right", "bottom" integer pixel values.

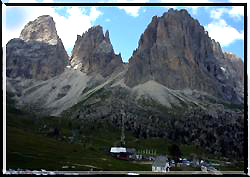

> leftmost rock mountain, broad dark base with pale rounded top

[{"left": 6, "top": 15, "right": 69, "bottom": 80}]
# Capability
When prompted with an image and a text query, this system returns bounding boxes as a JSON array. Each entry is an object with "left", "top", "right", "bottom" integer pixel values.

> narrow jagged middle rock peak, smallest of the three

[{"left": 71, "top": 26, "right": 123, "bottom": 77}]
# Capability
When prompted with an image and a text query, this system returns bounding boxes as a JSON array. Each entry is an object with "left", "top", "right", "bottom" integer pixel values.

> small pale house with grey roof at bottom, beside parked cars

[{"left": 152, "top": 156, "right": 170, "bottom": 172}]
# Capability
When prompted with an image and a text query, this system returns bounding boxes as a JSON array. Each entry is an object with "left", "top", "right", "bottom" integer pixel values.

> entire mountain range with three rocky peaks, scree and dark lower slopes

[{"left": 6, "top": 9, "right": 244, "bottom": 158}]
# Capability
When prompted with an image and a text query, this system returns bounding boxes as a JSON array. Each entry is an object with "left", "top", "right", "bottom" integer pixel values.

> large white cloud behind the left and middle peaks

[{"left": 3, "top": 0, "right": 102, "bottom": 53}]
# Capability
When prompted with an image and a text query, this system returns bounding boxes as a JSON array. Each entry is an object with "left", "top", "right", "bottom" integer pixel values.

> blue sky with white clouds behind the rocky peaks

[{"left": 3, "top": 0, "right": 244, "bottom": 62}]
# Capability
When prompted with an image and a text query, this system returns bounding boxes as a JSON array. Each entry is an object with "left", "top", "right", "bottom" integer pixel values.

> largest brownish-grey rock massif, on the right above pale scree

[{"left": 125, "top": 9, "right": 244, "bottom": 103}]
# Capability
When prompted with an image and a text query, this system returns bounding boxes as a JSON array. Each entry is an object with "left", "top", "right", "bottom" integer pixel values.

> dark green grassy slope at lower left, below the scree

[{"left": 7, "top": 105, "right": 151, "bottom": 171}]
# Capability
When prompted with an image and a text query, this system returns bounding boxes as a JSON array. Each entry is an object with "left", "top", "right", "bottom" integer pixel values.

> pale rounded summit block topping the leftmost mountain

[{"left": 20, "top": 15, "right": 59, "bottom": 45}]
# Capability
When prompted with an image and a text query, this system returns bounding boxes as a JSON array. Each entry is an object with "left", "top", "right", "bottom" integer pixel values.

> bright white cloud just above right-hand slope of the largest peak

[{"left": 205, "top": 19, "right": 244, "bottom": 47}]
